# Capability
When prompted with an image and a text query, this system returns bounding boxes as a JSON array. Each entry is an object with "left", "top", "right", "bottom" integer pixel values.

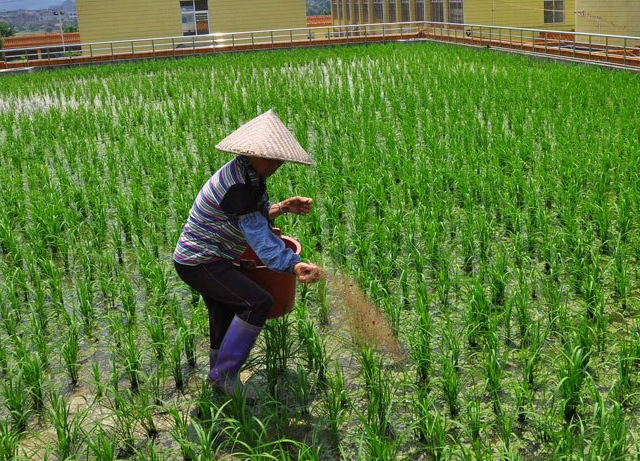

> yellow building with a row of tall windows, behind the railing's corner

[{"left": 331, "top": 0, "right": 576, "bottom": 30}]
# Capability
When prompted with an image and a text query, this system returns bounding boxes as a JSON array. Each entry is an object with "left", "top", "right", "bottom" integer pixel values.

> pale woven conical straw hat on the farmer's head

[{"left": 216, "top": 109, "right": 313, "bottom": 165}]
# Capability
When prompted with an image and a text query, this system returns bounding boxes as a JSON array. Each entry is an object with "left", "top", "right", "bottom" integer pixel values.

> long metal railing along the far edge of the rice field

[{"left": 0, "top": 21, "right": 640, "bottom": 69}]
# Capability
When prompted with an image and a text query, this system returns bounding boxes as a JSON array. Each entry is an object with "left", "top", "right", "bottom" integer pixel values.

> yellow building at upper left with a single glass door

[{"left": 76, "top": 0, "right": 307, "bottom": 47}]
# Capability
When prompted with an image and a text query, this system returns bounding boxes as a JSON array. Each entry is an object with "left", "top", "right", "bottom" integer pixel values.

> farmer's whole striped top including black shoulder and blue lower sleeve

[{"left": 173, "top": 156, "right": 300, "bottom": 272}]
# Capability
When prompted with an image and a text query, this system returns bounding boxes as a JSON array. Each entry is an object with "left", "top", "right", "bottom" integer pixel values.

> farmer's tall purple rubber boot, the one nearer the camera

[{"left": 209, "top": 315, "right": 262, "bottom": 397}]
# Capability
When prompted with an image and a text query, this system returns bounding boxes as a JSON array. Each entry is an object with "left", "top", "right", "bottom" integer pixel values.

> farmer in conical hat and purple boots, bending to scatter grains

[{"left": 173, "top": 110, "right": 320, "bottom": 395}]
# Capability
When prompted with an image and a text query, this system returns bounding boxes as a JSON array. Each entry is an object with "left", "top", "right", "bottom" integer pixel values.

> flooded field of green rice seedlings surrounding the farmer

[{"left": 0, "top": 42, "right": 640, "bottom": 461}]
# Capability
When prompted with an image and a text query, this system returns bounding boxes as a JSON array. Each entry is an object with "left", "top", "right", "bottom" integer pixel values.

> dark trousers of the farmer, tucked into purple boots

[{"left": 174, "top": 260, "right": 273, "bottom": 349}]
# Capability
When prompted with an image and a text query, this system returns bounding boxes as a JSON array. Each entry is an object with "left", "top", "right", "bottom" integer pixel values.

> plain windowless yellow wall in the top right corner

[{"left": 576, "top": 0, "right": 640, "bottom": 37}]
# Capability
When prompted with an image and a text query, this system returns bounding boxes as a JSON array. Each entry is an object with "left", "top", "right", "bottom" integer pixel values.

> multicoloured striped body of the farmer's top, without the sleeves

[{"left": 173, "top": 156, "right": 270, "bottom": 266}]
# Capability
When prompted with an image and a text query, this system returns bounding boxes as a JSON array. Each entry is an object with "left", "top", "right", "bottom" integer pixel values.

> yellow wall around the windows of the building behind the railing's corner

[{"left": 331, "top": 0, "right": 576, "bottom": 30}]
